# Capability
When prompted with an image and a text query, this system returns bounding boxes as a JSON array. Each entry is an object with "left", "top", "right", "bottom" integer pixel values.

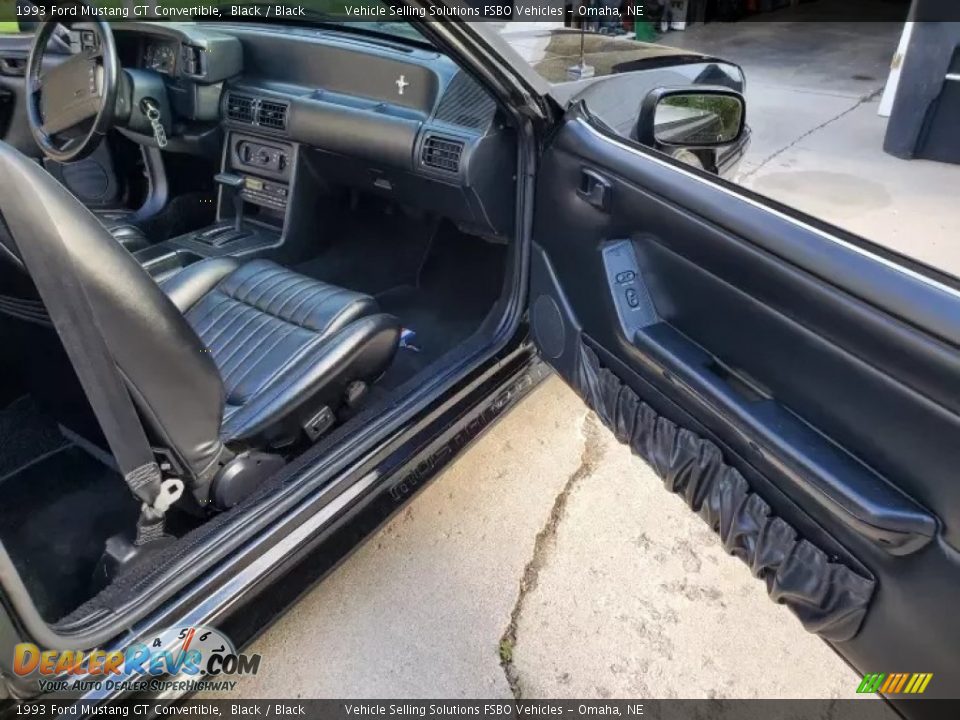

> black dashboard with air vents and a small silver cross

[{"left": 114, "top": 22, "right": 516, "bottom": 235}]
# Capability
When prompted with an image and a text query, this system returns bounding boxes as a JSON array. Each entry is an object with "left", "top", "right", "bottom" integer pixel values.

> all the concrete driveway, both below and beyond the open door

[{"left": 221, "top": 15, "right": 948, "bottom": 712}]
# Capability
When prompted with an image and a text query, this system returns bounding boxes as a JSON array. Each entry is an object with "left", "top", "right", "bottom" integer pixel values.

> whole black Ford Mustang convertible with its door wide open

[{"left": 0, "top": 0, "right": 960, "bottom": 714}]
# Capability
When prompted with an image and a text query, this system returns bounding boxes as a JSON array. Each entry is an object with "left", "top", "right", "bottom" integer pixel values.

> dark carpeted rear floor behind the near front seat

[{"left": 0, "top": 445, "right": 138, "bottom": 621}]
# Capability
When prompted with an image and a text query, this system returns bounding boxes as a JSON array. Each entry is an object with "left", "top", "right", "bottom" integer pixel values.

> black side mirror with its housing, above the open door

[{"left": 636, "top": 87, "right": 747, "bottom": 148}]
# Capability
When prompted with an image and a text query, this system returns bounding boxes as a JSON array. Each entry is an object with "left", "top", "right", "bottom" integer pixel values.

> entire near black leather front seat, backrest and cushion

[{"left": 0, "top": 142, "right": 400, "bottom": 505}]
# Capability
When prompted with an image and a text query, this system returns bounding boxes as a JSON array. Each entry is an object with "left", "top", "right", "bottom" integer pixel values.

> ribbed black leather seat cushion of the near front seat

[{"left": 162, "top": 258, "right": 399, "bottom": 445}]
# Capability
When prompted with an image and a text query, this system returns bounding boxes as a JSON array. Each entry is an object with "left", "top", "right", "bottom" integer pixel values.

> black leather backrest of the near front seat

[{"left": 0, "top": 142, "right": 231, "bottom": 484}]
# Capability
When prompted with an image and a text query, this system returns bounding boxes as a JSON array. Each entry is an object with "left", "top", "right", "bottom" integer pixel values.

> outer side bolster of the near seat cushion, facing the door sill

[{"left": 220, "top": 313, "right": 400, "bottom": 446}]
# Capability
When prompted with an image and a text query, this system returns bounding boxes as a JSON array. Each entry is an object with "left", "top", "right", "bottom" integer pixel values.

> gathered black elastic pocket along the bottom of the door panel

[{"left": 574, "top": 341, "right": 876, "bottom": 642}]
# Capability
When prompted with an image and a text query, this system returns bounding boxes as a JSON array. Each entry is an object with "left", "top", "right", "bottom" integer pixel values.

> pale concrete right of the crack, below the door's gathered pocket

[{"left": 512, "top": 424, "right": 857, "bottom": 698}]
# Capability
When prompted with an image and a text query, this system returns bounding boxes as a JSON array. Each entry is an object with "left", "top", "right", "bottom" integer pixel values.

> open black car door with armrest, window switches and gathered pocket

[{"left": 529, "top": 105, "right": 960, "bottom": 716}]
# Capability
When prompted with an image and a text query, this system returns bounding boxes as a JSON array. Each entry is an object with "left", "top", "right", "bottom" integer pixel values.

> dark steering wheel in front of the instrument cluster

[{"left": 26, "top": 20, "right": 120, "bottom": 163}]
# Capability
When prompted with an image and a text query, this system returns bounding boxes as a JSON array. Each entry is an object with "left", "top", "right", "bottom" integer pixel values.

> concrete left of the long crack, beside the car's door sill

[{"left": 206, "top": 379, "right": 587, "bottom": 698}]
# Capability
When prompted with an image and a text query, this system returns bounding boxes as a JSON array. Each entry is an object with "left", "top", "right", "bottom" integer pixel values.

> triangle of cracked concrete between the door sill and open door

[{"left": 219, "top": 377, "right": 872, "bottom": 698}]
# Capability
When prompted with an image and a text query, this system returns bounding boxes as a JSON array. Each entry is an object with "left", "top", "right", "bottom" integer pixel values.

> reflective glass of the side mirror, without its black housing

[{"left": 654, "top": 93, "right": 743, "bottom": 147}]
